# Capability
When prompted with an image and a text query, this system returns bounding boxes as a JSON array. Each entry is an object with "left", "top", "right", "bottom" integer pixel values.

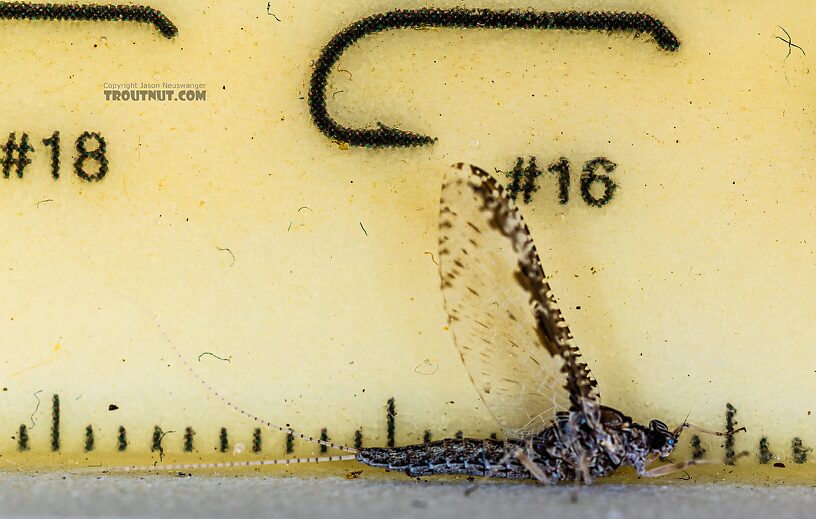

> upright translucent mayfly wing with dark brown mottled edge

[{"left": 439, "top": 164, "right": 596, "bottom": 437}]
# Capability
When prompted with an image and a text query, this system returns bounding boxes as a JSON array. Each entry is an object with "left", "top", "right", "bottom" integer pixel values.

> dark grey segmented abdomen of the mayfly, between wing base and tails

[{"left": 357, "top": 438, "right": 531, "bottom": 479}]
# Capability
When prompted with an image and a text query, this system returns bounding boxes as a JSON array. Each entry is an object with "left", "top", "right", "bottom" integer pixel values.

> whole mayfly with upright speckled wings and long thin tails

[{"left": 102, "top": 164, "right": 740, "bottom": 484}]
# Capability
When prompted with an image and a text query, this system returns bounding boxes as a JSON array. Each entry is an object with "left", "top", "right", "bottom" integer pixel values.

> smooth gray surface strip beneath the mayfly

[{"left": 0, "top": 474, "right": 816, "bottom": 519}]
